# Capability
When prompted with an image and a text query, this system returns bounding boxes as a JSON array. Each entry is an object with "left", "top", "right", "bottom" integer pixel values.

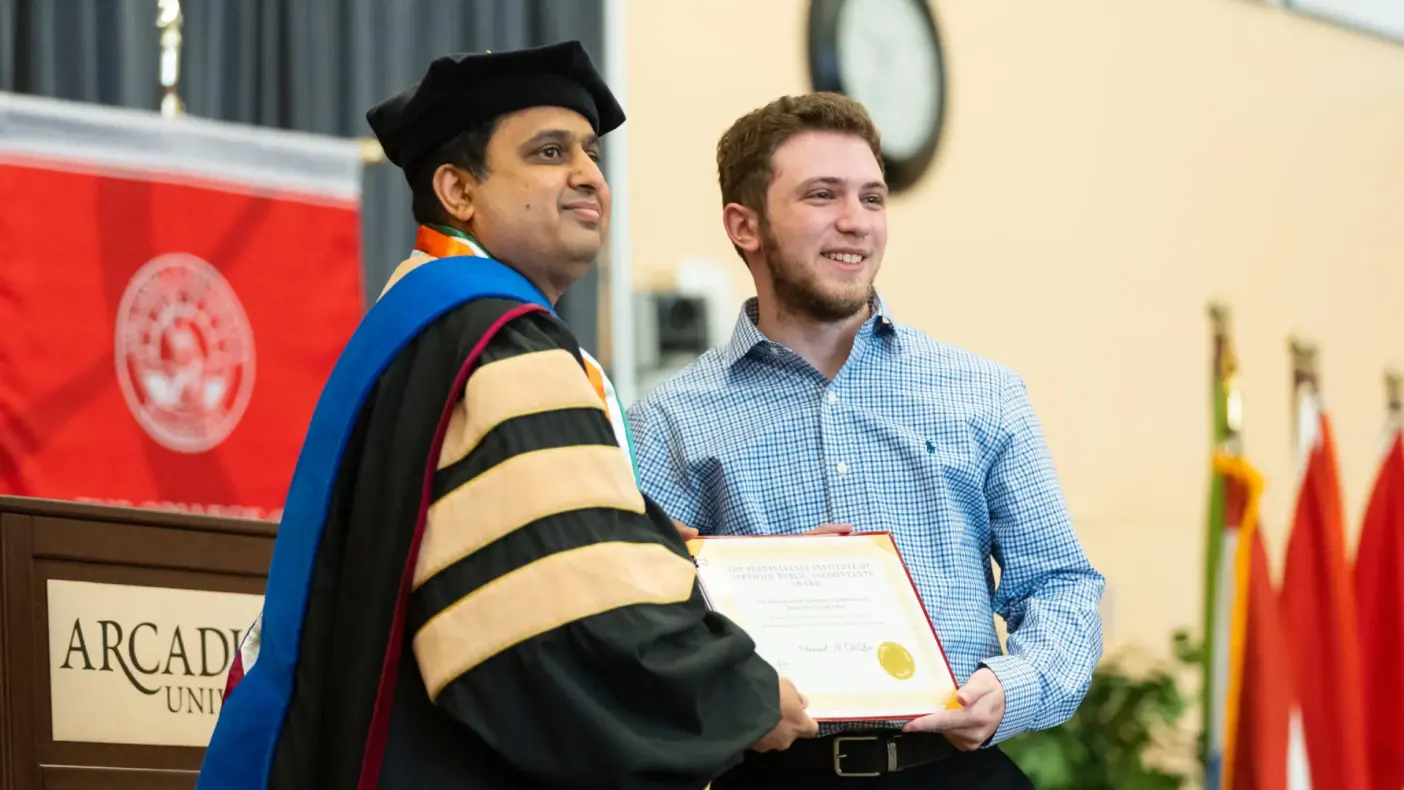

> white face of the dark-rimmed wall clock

[{"left": 838, "top": 0, "right": 941, "bottom": 159}]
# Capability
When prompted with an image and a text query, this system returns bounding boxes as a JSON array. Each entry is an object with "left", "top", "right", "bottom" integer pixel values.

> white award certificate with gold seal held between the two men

[{"left": 688, "top": 532, "right": 959, "bottom": 721}]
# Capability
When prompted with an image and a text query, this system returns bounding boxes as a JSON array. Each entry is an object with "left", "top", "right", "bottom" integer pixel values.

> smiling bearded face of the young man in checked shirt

[{"left": 733, "top": 132, "right": 887, "bottom": 321}]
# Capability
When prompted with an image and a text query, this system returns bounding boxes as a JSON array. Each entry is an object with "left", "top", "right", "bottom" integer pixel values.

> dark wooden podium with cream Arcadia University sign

[{"left": 0, "top": 497, "right": 277, "bottom": 790}]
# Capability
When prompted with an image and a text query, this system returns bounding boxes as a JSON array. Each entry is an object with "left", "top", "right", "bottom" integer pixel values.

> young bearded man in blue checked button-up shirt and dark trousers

[{"left": 629, "top": 94, "right": 1104, "bottom": 790}]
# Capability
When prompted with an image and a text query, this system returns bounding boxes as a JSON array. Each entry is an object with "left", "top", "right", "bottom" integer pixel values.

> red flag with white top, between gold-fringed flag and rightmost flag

[{"left": 1282, "top": 396, "right": 1369, "bottom": 790}]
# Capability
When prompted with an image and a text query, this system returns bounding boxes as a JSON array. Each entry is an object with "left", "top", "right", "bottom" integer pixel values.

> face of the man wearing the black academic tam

[{"left": 435, "top": 107, "right": 609, "bottom": 300}]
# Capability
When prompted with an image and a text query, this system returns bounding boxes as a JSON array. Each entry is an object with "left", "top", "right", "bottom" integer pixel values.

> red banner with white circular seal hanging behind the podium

[{"left": 0, "top": 94, "right": 364, "bottom": 518}]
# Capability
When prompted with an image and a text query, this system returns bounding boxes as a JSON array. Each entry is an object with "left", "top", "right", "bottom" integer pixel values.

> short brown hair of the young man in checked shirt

[{"left": 716, "top": 93, "right": 882, "bottom": 216}]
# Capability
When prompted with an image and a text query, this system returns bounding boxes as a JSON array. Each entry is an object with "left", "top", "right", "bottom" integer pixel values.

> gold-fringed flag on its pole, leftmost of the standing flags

[{"left": 1203, "top": 312, "right": 1290, "bottom": 790}]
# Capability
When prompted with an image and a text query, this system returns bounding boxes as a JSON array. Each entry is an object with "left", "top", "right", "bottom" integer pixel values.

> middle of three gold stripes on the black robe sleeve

[{"left": 414, "top": 445, "right": 644, "bottom": 589}]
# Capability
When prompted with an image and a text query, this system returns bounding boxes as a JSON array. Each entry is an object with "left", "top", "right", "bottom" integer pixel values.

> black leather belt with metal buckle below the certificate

[{"left": 771, "top": 732, "right": 959, "bottom": 777}]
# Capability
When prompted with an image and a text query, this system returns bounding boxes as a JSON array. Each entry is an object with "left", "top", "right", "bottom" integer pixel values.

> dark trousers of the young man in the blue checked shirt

[{"left": 712, "top": 732, "right": 1033, "bottom": 790}]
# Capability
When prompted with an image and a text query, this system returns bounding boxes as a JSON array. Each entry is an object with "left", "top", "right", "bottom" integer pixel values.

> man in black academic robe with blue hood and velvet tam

[{"left": 199, "top": 42, "right": 817, "bottom": 790}]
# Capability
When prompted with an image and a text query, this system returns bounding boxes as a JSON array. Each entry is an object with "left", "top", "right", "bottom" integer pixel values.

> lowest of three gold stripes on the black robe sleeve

[{"left": 414, "top": 542, "right": 696, "bottom": 699}]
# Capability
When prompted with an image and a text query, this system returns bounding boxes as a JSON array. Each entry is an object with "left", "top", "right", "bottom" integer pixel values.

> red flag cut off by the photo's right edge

[{"left": 1355, "top": 431, "right": 1404, "bottom": 790}]
